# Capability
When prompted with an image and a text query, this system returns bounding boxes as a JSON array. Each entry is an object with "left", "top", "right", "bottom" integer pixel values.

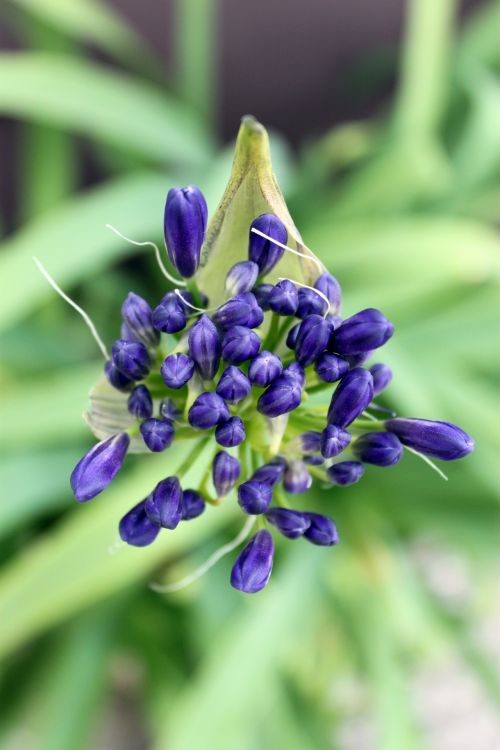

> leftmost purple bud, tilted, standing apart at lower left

[{"left": 70, "top": 432, "right": 130, "bottom": 503}]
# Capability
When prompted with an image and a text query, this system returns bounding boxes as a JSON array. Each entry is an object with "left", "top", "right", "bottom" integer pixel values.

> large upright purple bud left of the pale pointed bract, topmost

[{"left": 163, "top": 185, "right": 208, "bottom": 279}]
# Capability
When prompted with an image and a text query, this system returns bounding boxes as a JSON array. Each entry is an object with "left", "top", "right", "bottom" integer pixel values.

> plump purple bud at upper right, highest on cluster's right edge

[{"left": 330, "top": 307, "right": 394, "bottom": 354}]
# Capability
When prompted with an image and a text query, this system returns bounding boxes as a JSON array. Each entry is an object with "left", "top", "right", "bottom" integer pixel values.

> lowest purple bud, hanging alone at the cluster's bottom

[{"left": 231, "top": 529, "right": 274, "bottom": 594}]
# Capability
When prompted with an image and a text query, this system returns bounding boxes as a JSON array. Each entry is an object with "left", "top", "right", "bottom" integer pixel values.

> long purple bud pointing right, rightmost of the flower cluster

[{"left": 385, "top": 417, "right": 475, "bottom": 461}]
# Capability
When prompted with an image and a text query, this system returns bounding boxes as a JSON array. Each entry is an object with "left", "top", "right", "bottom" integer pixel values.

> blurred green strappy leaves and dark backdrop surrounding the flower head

[{"left": 0, "top": 0, "right": 500, "bottom": 750}]
